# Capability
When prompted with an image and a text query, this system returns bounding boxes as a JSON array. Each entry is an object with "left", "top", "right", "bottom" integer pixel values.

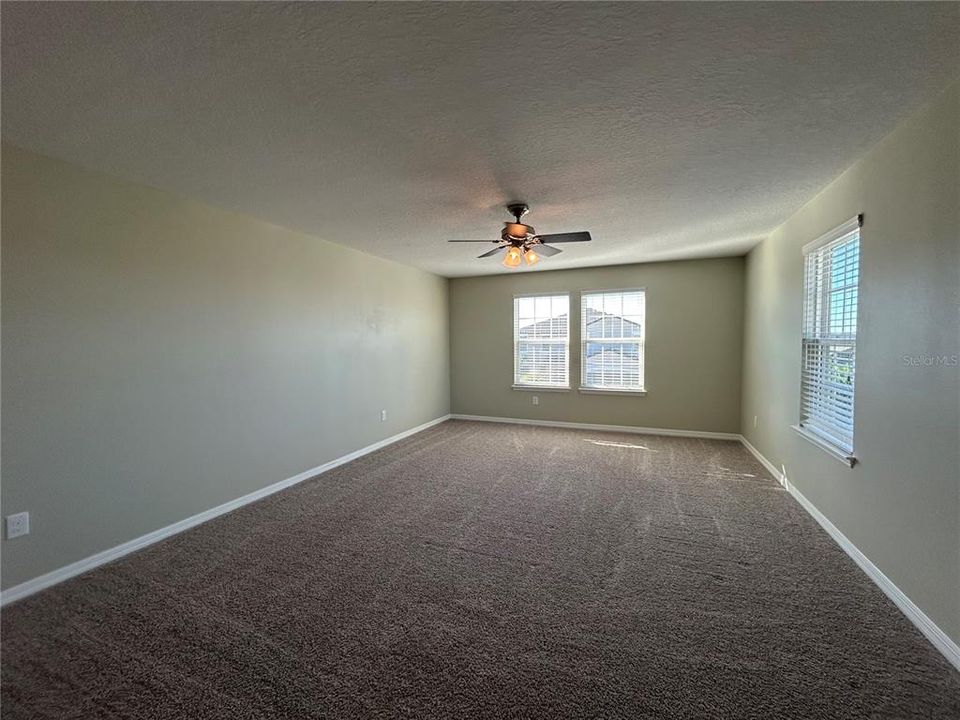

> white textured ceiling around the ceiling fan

[{"left": 2, "top": 2, "right": 960, "bottom": 276}]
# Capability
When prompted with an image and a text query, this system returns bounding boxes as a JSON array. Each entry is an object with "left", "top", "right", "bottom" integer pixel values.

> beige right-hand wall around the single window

[{"left": 743, "top": 85, "right": 960, "bottom": 641}]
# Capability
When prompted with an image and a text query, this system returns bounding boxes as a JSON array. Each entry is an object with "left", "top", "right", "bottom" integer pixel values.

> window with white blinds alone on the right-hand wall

[{"left": 800, "top": 217, "right": 860, "bottom": 458}]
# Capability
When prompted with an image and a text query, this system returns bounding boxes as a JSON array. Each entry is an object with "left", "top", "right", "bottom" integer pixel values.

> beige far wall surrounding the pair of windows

[{"left": 450, "top": 258, "right": 743, "bottom": 432}]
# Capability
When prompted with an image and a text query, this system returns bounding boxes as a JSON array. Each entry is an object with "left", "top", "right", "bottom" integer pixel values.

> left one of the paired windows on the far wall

[{"left": 513, "top": 294, "right": 570, "bottom": 388}]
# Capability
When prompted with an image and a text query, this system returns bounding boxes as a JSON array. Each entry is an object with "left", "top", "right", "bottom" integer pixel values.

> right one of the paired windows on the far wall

[{"left": 580, "top": 290, "right": 646, "bottom": 392}]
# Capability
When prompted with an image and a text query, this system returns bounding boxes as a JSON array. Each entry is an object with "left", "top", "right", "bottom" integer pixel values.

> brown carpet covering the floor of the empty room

[{"left": 2, "top": 421, "right": 960, "bottom": 720}]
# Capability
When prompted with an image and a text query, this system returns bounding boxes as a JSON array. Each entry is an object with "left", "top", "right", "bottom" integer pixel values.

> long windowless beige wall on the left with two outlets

[{"left": 2, "top": 145, "right": 449, "bottom": 587}]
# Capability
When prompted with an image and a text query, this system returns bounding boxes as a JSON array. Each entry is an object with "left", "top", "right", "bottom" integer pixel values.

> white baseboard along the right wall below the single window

[{"left": 740, "top": 436, "right": 960, "bottom": 670}]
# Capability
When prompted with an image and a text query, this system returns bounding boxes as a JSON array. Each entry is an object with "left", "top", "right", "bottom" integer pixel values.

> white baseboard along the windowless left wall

[{"left": 0, "top": 415, "right": 450, "bottom": 606}]
